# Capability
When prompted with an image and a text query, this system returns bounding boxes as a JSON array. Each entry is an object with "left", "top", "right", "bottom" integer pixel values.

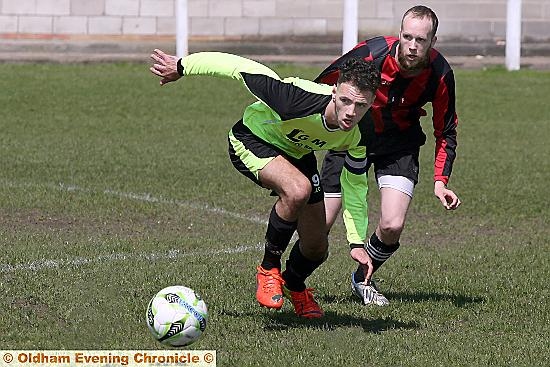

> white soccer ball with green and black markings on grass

[{"left": 147, "top": 285, "right": 208, "bottom": 347}]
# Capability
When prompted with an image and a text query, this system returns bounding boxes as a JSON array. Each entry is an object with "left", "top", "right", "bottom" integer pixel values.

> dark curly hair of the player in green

[{"left": 337, "top": 57, "right": 380, "bottom": 93}]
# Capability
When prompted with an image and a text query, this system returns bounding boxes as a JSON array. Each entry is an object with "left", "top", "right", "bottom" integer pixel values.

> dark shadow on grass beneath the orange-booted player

[{"left": 264, "top": 310, "right": 420, "bottom": 334}]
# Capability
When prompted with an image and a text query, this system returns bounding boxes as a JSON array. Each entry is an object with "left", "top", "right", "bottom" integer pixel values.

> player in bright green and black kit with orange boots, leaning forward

[{"left": 150, "top": 50, "right": 380, "bottom": 318}]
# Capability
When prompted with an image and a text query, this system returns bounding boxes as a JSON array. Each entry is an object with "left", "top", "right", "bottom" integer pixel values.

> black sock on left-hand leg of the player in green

[{"left": 261, "top": 206, "right": 297, "bottom": 270}]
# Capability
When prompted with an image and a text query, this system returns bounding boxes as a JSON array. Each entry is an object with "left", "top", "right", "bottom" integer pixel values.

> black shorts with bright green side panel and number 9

[{"left": 228, "top": 120, "right": 324, "bottom": 204}]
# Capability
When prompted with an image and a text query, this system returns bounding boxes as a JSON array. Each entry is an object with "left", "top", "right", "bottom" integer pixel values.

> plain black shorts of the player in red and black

[{"left": 321, "top": 149, "right": 420, "bottom": 193}]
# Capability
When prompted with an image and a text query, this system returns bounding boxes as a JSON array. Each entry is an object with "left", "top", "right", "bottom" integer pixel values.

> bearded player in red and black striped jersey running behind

[{"left": 316, "top": 6, "right": 460, "bottom": 306}]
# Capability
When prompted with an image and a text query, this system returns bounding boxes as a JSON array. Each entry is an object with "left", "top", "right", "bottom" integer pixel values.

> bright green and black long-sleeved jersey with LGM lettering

[{"left": 180, "top": 52, "right": 368, "bottom": 243}]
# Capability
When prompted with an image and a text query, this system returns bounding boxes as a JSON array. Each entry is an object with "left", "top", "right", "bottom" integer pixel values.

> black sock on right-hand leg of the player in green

[{"left": 283, "top": 240, "right": 328, "bottom": 292}]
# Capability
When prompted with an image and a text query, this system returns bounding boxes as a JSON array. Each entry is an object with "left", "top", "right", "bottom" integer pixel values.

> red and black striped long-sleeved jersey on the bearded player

[{"left": 316, "top": 37, "right": 458, "bottom": 184}]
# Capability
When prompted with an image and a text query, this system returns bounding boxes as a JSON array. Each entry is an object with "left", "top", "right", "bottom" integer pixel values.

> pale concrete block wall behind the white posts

[{"left": 0, "top": 0, "right": 550, "bottom": 41}]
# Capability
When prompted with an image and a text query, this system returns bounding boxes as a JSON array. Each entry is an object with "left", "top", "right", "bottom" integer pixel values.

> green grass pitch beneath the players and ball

[{"left": 0, "top": 64, "right": 550, "bottom": 366}]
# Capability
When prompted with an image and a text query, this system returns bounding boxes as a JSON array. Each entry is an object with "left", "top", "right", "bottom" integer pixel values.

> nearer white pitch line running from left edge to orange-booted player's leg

[{"left": 0, "top": 243, "right": 263, "bottom": 273}]
